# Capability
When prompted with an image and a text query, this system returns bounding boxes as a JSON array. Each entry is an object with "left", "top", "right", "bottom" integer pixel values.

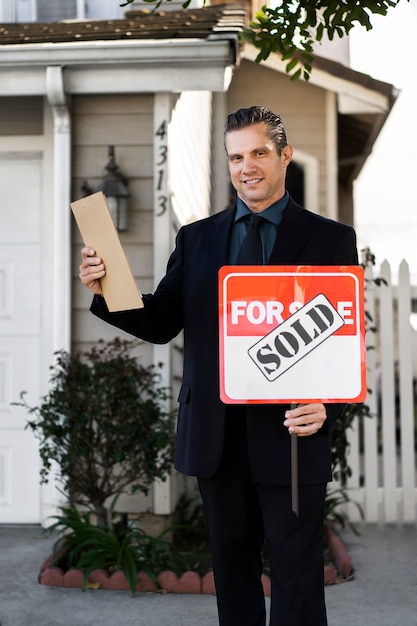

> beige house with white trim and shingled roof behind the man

[{"left": 0, "top": 3, "right": 396, "bottom": 523}]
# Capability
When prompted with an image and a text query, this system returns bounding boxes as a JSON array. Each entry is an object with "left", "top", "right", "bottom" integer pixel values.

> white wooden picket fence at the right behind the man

[{"left": 347, "top": 261, "right": 417, "bottom": 524}]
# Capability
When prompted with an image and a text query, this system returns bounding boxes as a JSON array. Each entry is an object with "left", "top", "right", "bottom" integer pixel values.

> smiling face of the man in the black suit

[{"left": 226, "top": 123, "right": 293, "bottom": 213}]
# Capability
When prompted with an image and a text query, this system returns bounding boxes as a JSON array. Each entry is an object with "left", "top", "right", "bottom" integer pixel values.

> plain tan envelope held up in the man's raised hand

[{"left": 71, "top": 191, "right": 143, "bottom": 312}]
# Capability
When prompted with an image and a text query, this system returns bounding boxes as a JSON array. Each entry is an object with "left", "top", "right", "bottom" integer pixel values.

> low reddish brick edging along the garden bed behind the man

[{"left": 38, "top": 528, "right": 353, "bottom": 596}]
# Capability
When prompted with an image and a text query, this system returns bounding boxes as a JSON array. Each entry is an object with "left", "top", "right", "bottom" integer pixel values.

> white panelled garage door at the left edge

[{"left": 0, "top": 152, "right": 42, "bottom": 523}]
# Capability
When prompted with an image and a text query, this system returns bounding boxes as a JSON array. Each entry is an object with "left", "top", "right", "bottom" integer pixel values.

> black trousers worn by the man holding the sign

[{"left": 198, "top": 407, "right": 327, "bottom": 626}]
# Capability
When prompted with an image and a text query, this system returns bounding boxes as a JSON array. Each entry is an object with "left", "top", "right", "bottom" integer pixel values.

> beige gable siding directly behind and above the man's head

[{"left": 228, "top": 60, "right": 328, "bottom": 215}]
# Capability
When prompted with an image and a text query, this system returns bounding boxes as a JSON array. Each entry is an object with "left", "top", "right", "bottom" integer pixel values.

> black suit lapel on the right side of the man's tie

[{"left": 268, "top": 198, "right": 310, "bottom": 265}]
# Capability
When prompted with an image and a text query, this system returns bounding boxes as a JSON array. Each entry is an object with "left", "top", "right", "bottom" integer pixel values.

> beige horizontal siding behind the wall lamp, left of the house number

[{"left": 72, "top": 95, "right": 153, "bottom": 362}]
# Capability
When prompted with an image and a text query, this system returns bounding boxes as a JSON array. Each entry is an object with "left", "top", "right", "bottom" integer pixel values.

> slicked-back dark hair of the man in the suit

[{"left": 224, "top": 106, "right": 287, "bottom": 154}]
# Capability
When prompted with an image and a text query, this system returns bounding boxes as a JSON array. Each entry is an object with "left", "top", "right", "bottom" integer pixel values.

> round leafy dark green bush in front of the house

[{"left": 17, "top": 338, "right": 174, "bottom": 529}]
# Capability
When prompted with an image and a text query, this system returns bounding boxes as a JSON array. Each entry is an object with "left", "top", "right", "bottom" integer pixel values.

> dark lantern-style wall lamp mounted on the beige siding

[{"left": 81, "top": 146, "right": 130, "bottom": 232}]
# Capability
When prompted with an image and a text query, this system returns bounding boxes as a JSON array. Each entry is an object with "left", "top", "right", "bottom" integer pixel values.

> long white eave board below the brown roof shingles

[{"left": 0, "top": 33, "right": 238, "bottom": 96}]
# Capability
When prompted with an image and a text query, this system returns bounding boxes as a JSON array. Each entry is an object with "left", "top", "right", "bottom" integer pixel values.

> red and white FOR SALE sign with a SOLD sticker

[{"left": 219, "top": 265, "right": 366, "bottom": 404}]
